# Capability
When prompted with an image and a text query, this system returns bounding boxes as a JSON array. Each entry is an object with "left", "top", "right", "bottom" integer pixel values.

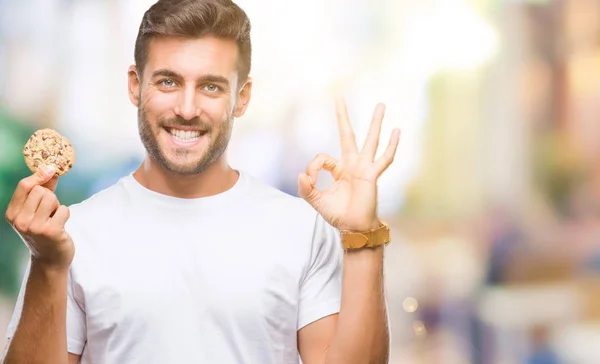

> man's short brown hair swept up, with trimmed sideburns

[{"left": 134, "top": 0, "right": 252, "bottom": 85}]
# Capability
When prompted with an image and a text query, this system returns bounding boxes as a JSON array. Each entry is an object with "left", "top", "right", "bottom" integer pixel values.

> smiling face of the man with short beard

[{"left": 129, "top": 37, "right": 251, "bottom": 175}]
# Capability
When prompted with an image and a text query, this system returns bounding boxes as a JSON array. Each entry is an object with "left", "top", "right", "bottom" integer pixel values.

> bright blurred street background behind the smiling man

[{"left": 0, "top": 0, "right": 600, "bottom": 364}]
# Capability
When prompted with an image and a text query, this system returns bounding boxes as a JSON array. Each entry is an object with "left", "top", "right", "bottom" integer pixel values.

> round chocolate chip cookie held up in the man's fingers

[{"left": 23, "top": 129, "right": 75, "bottom": 176}]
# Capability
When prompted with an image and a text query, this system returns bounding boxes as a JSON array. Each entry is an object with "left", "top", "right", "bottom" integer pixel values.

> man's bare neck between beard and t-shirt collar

[{"left": 133, "top": 156, "right": 239, "bottom": 198}]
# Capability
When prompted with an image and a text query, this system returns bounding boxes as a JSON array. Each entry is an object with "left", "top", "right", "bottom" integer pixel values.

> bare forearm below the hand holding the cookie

[{"left": 3, "top": 262, "right": 68, "bottom": 364}]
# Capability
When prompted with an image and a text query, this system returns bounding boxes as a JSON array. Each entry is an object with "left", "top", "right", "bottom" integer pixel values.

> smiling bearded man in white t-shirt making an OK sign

[{"left": 4, "top": 0, "right": 399, "bottom": 364}]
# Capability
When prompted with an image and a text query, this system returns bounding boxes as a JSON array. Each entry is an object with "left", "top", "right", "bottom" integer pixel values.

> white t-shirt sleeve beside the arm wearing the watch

[{"left": 298, "top": 215, "right": 343, "bottom": 330}]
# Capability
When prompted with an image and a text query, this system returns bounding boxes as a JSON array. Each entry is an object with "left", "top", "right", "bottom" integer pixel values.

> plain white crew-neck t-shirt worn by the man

[{"left": 7, "top": 172, "right": 342, "bottom": 364}]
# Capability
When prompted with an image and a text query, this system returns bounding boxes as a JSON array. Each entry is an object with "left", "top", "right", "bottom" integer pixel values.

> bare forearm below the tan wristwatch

[{"left": 325, "top": 246, "right": 389, "bottom": 364}]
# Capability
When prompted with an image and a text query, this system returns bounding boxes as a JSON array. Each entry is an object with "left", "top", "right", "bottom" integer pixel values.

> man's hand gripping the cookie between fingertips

[{"left": 6, "top": 167, "right": 75, "bottom": 270}]
